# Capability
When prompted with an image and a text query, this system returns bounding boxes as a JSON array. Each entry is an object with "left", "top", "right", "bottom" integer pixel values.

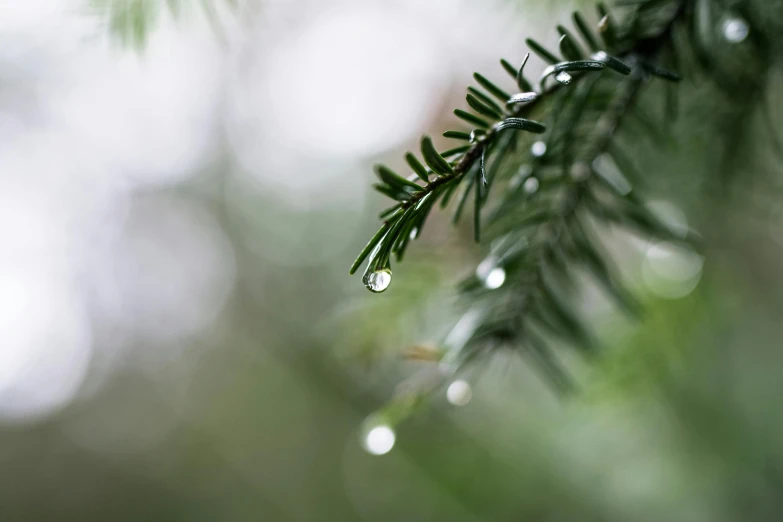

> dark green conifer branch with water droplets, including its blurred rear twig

[{"left": 351, "top": 0, "right": 692, "bottom": 389}]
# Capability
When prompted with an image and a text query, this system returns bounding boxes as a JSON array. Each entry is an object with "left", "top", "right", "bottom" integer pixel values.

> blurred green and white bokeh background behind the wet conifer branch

[{"left": 0, "top": 0, "right": 783, "bottom": 522}]
